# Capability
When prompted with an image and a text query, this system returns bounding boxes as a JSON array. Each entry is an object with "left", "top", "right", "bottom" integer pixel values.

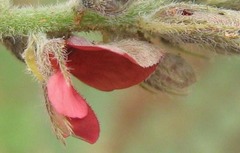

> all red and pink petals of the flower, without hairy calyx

[{"left": 47, "top": 37, "right": 162, "bottom": 143}]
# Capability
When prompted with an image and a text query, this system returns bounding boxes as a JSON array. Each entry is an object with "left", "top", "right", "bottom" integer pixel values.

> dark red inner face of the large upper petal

[{"left": 67, "top": 37, "right": 156, "bottom": 91}]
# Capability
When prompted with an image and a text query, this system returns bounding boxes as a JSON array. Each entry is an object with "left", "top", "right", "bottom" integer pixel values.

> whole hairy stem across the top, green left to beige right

[{"left": 0, "top": 0, "right": 240, "bottom": 54}]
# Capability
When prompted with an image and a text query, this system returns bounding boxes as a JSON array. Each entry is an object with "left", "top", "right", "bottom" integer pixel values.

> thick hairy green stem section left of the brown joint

[{"left": 0, "top": 0, "right": 81, "bottom": 36}]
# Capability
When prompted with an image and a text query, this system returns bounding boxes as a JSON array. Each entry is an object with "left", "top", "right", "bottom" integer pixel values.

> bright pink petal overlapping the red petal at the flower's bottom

[{"left": 47, "top": 71, "right": 88, "bottom": 118}]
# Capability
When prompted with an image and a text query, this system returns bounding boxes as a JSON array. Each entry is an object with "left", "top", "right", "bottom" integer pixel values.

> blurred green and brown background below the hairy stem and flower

[{"left": 0, "top": 0, "right": 240, "bottom": 153}]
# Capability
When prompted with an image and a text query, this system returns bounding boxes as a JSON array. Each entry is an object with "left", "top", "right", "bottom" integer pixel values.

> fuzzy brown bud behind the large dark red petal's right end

[{"left": 144, "top": 53, "right": 196, "bottom": 94}]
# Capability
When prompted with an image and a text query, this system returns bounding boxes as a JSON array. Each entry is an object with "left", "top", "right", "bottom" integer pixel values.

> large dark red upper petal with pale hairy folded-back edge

[{"left": 67, "top": 37, "right": 162, "bottom": 91}]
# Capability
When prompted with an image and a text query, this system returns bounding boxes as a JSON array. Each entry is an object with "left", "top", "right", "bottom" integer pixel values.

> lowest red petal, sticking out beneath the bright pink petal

[{"left": 68, "top": 106, "right": 100, "bottom": 144}]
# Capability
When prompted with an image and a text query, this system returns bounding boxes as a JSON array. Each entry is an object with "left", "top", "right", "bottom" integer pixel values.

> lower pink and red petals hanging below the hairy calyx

[{"left": 47, "top": 71, "right": 100, "bottom": 143}]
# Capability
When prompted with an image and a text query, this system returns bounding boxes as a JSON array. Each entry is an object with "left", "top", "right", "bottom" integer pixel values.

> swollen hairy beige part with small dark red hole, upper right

[{"left": 140, "top": 3, "right": 240, "bottom": 54}]
